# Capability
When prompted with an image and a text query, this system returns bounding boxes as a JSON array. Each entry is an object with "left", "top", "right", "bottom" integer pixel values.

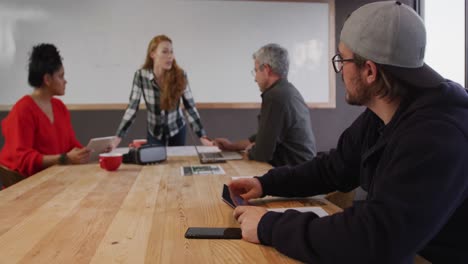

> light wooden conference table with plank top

[{"left": 0, "top": 150, "right": 340, "bottom": 263}]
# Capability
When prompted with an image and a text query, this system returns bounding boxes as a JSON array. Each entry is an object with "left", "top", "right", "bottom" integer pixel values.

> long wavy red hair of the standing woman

[{"left": 141, "top": 35, "right": 187, "bottom": 110}]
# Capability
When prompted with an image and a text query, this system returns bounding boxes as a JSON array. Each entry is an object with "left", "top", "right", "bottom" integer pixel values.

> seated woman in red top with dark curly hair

[{"left": 0, "top": 44, "right": 90, "bottom": 190}]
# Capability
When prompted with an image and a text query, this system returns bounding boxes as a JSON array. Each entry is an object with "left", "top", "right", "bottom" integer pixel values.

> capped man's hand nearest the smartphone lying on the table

[{"left": 233, "top": 206, "right": 267, "bottom": 244}]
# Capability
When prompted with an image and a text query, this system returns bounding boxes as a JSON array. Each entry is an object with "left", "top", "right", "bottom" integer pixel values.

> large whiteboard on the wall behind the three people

[{"left": 0, "top": 0, "right": 335, "bottom": 106}]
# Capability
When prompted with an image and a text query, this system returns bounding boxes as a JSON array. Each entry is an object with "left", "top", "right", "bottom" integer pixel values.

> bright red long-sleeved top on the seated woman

[{"left": 0, "top": 95, "right": 82, "bottom": 177}]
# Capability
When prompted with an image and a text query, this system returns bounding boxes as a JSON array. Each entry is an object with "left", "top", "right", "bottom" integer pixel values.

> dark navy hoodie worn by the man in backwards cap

[{"left": 258, "top": 81, "right": 468, "bottom": 263}]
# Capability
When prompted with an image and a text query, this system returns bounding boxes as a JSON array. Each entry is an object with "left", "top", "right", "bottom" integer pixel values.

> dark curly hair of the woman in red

[{"left": 28, "top": 43, "right": 62, "bottom": 88}]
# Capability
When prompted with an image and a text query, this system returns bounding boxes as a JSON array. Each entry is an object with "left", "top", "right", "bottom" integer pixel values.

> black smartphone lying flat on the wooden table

[{"left": 185, "top": 227, "right": 242, "bottom": 239}]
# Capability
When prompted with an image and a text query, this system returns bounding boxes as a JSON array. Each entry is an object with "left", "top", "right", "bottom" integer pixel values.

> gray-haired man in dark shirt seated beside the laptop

[{"left": 215, "top": 44, "right": 315, "bottom": 166}]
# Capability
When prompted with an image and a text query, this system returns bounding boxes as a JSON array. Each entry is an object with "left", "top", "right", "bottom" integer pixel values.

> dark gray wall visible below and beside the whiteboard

[{"left": 0, "top": 0, "right": 417, "bottom": 151}]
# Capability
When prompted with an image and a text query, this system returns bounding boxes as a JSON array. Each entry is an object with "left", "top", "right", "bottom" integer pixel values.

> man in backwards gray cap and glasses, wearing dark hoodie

[{"left": 229, "top": 1, "right": 468, "bottom": 263}]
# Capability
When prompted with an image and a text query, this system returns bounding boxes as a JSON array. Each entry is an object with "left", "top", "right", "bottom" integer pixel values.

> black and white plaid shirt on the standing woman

[{"left": 116, "top": 69, "right": 206, "bottom": 140}]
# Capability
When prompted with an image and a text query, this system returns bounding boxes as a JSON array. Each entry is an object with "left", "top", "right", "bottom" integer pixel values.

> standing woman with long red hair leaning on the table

[{"left": 115, "top": 35, "right": 212, "bottom": 146}]
